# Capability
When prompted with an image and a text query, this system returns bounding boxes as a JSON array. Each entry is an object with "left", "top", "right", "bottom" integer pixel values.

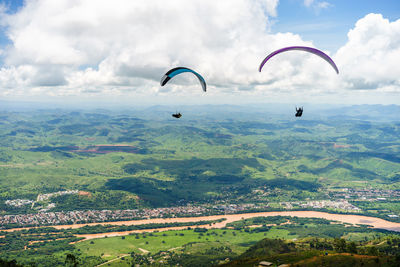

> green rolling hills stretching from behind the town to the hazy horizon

[{"left": 0, "top": 108, "right": 400, "bottom": 211}]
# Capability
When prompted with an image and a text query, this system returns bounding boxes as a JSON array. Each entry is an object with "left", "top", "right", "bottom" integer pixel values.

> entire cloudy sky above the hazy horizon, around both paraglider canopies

[{"left": 0, "top": 0, "right": 400, "bottom": 107}]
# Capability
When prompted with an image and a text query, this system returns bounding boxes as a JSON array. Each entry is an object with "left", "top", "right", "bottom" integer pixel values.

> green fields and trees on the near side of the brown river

[{"left": 1, "top": 216, "right": 400, "bottom": 266}]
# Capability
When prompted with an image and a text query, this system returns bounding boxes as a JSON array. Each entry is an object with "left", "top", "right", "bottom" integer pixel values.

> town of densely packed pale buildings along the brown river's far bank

[{"left": 0, "top": 188, "right": 400, "bottom": 228}]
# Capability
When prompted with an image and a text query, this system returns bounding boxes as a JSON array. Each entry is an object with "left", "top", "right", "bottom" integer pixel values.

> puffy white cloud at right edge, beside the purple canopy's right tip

[{"left": 335, "top": 14, "right": 400, "bottom": 92}]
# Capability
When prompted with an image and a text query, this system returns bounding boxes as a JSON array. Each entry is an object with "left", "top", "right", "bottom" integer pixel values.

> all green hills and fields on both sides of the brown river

[{"left": 0, "top": 106, "right": 400, "bottom": 266}]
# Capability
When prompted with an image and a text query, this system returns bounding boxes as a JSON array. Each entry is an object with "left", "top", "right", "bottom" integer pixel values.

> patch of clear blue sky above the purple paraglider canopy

[{"left": 272, "top": 0, "right": 400, "bottom": 52}]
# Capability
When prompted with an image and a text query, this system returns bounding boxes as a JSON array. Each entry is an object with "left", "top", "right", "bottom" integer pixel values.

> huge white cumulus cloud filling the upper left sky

[{"left": 2, "top": 0, "right": 286, "bottom": 95}]
